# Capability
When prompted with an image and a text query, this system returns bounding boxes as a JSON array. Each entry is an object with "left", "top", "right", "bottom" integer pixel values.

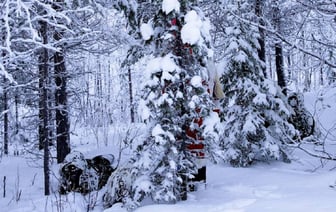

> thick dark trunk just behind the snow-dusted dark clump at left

[{"left": 53, "top": 0, "right": 70, "bottom": 163}]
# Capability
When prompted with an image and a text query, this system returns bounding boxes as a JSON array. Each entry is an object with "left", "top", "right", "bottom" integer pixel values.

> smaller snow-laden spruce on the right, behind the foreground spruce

[{"left": 221, "top": 0, "right": 297, "bottom": 166}]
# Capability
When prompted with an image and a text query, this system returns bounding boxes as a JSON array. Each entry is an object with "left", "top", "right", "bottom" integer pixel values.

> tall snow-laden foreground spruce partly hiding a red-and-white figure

[{"left": 105, "top": 0, "right": 223, "bottom": 210}]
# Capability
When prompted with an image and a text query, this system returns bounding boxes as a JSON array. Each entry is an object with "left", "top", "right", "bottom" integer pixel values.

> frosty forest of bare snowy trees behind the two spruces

[{"left": 0, "top": 0, "right": 336, "bottom": 211}]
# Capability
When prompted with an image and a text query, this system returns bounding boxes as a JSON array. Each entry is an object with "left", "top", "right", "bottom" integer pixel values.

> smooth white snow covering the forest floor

[{"left": 0, "top": 89, "right": 336, "bottom": 212}]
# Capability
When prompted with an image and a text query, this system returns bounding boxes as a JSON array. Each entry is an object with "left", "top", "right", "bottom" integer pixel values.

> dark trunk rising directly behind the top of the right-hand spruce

[{"left": 255, "top": 0, "right": 267, "bottom": 77}]
